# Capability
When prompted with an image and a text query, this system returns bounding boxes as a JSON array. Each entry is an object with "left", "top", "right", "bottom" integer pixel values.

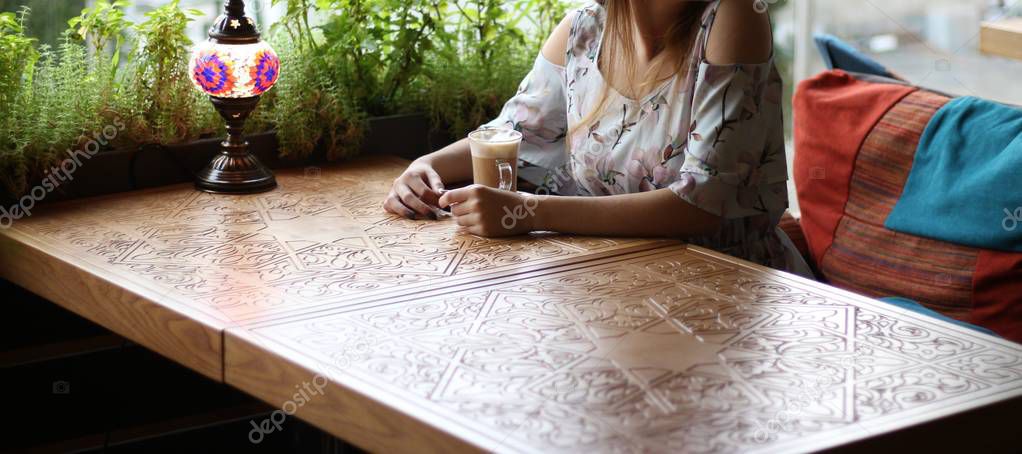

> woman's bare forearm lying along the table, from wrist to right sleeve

[{"left": 531, "top": 189, "right": 721, "bottom": 238}]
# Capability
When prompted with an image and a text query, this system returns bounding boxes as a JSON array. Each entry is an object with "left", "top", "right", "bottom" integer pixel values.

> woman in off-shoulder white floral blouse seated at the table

[{"left": 384, "top": 0, "right": 803, "bottom": 271}]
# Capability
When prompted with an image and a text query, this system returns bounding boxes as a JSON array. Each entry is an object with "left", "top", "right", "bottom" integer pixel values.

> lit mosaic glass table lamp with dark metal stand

[{"left": 188, "top": 0, "right": 280, "bottom": 193}]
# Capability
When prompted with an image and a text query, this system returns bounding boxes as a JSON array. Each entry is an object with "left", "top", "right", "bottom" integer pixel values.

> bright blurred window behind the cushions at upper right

[{"left": 796, "top": 0, "right": 1022, "bottom": 104}]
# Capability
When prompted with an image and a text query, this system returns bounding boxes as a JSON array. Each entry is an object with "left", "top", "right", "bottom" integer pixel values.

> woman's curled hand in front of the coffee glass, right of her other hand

[{"left": 439, "top": 184, "right": 539, "bottom": 237}]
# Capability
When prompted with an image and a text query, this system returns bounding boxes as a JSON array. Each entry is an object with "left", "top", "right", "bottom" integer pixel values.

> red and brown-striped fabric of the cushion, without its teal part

[{"left": 794, "top": 71, "right": 1022, "bottom": 342}]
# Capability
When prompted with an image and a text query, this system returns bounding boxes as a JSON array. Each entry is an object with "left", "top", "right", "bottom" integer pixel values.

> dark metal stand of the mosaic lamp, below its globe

[{"left": 195, "top": 96, "right": 277, "bottom": 194}]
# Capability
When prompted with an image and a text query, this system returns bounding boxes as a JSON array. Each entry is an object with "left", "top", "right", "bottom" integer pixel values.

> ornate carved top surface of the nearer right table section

[{"left": 256, "top": 248, "right": 1022, "bottom": 452}]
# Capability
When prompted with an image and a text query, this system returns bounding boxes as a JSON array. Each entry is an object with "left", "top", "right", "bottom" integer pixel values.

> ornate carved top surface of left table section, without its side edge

[{"left": 16, "top": 160, "right": 658, "bottom": 322}]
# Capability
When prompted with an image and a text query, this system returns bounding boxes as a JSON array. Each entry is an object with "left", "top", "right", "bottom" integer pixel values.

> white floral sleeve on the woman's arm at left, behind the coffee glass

[{"left": 483, "top": 54, "right": 567, "bottom": 185}]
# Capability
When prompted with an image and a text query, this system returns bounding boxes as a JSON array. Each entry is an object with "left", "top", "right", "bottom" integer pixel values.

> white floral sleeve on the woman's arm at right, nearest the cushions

[{"left": 670, "top": 60, "right": 788, "bottom": 219}]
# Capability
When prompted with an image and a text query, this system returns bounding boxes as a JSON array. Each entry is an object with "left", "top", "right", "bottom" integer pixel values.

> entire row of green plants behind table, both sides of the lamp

[{"left": 0, "top": 0, "right": 576, "bottom": 198}]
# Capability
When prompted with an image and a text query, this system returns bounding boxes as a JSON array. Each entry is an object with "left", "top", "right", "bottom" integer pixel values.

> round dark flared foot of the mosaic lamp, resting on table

[{"left": 195, "top": 151, "right": 277, "bottom": 194}]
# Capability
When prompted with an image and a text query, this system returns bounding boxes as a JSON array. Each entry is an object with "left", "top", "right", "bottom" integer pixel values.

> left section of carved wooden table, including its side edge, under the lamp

[{"left": 0, "top": 158, "right": 669, "bottom": 380}]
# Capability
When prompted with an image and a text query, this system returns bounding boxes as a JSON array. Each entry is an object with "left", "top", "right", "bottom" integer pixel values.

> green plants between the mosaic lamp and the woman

[{"left": 257, "top": 0, "right": 543, "bottom": 157}]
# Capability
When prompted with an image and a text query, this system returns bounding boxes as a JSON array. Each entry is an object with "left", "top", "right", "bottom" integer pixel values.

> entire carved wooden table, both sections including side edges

[{"left": 0, "top": 155, "right": 1022, "bottom": 452}]
